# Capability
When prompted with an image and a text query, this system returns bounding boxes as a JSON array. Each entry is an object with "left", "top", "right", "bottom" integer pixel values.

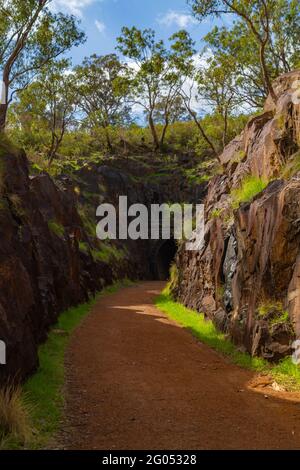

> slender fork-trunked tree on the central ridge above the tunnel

[{"left": 118, "top": 27, "right": 195, "bottom": 151}]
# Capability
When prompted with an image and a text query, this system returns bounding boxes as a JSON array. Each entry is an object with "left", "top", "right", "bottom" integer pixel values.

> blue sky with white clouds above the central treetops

[{"left": 53, "top": 0, "right": 225, "bottom": 64}]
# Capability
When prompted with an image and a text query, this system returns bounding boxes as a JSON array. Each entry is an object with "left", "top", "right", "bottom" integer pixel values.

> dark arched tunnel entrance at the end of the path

[{"left": 152, "top": 239, "right": 177, "bottom": 281}]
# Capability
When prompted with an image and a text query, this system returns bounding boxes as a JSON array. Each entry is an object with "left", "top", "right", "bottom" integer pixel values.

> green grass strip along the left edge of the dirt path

[{"left": 0, "top": 279, "right": 132, "bottom": 449}]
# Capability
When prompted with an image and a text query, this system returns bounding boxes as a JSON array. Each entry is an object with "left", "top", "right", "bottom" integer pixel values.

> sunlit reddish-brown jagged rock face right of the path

[{"left": 173, "top": 72, "right": 300, "bottom": 360}]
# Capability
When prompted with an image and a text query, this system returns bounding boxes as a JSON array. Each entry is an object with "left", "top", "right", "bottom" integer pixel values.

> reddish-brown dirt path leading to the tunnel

[{"left": 62, "top": 282, "right": 300, "bottom": 450}]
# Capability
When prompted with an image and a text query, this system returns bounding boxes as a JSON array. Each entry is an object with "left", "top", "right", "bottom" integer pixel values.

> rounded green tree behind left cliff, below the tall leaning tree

[{"left": 14, "top": 60, "right": 77, "bottom": 165}]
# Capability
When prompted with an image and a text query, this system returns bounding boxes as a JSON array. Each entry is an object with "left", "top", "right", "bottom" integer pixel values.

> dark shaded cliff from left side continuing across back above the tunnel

[{"left": 0, "top": 145, "right": 207, "bottom": 383}]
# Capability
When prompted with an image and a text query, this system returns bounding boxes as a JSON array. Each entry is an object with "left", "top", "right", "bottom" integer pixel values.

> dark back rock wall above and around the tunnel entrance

[{"left": 72, "top": 156, "right": 207, "bottom": 279}]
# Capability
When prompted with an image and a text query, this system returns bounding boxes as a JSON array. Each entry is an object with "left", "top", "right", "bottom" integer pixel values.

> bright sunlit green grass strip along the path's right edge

[{"left": 156, "top": 289, "right": 300, "bottom": 391}]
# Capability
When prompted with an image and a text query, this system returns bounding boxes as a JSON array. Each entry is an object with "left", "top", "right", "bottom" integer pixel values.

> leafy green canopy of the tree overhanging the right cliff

[{"left": 188, "top": 0, "right": 300, "bottom": 107}]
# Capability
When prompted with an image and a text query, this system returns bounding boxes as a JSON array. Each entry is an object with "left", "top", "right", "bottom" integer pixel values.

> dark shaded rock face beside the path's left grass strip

[{"left": 0, "top": 149, "right": 128, "bottom": 382}]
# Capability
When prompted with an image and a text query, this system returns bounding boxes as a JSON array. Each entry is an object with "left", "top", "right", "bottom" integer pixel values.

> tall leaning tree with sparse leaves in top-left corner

[{"left": 0, "top": 0, "right": 85, "bottom": 131}]
